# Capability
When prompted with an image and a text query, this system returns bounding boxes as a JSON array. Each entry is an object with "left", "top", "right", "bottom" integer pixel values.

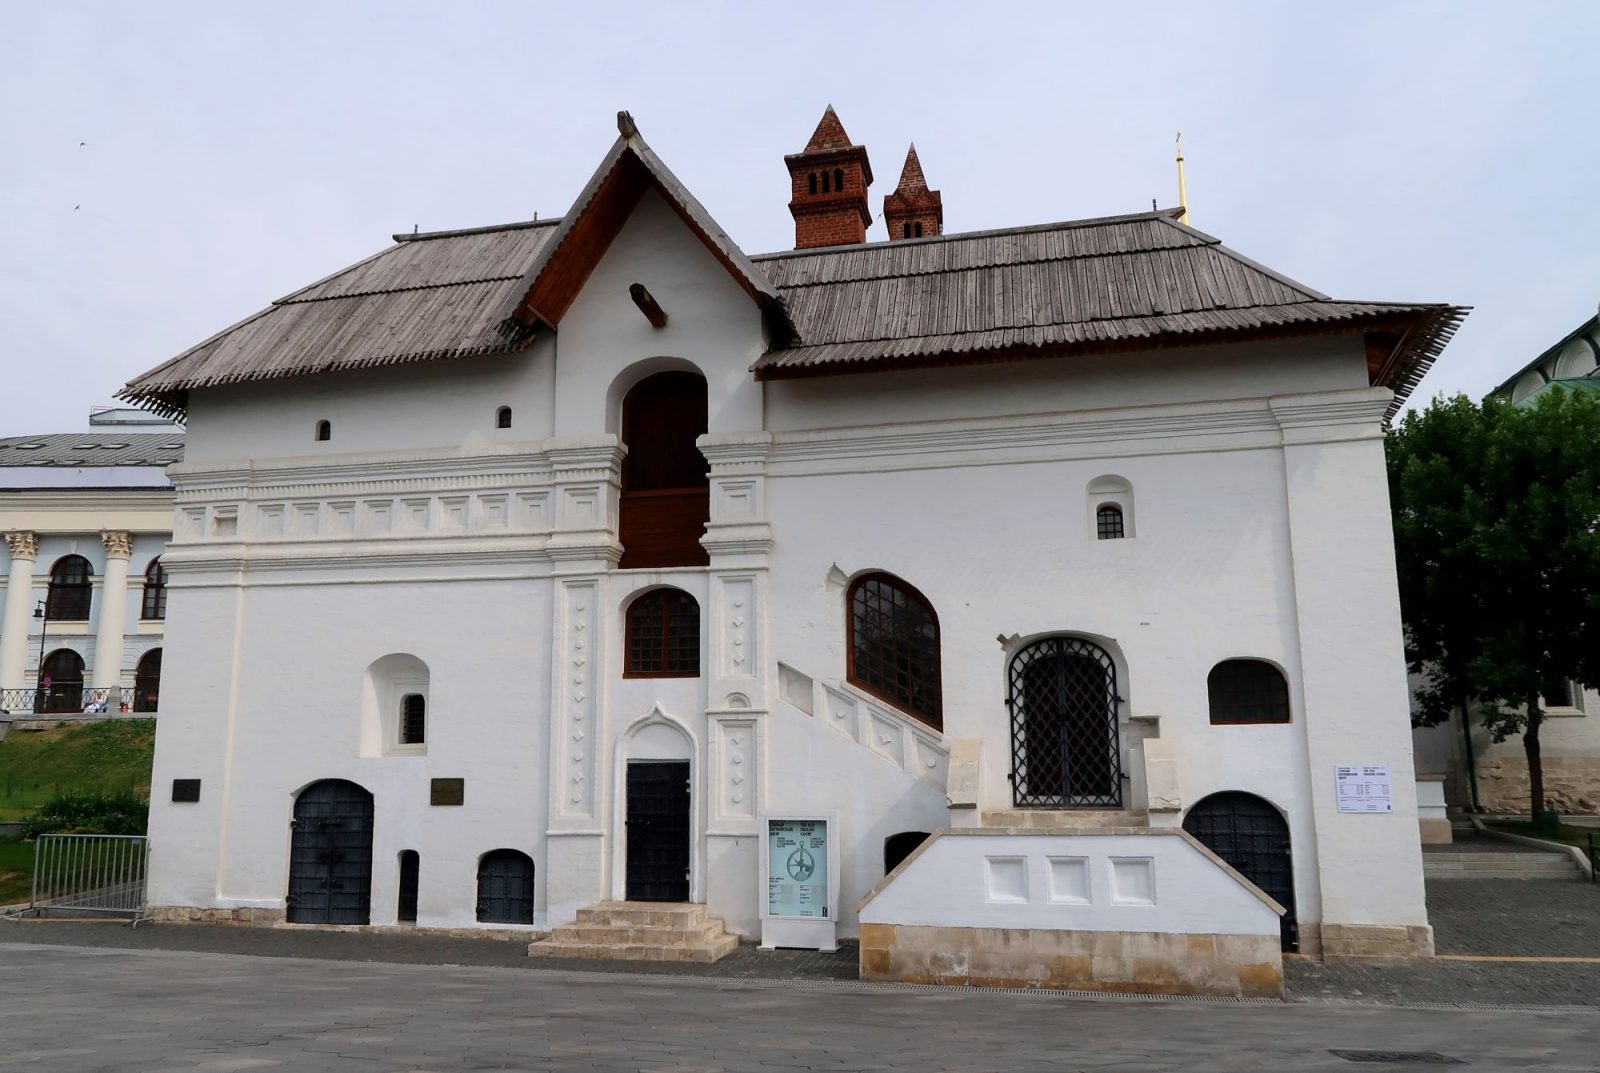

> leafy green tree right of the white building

[{"left": 1387, "top": 389, "right": 1600, "bottom": 819}]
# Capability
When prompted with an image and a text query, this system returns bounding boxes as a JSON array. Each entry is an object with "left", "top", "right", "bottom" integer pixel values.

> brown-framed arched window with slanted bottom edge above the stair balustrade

[{"left": 846, "top": 574, "right": 944, "bottom": 731}]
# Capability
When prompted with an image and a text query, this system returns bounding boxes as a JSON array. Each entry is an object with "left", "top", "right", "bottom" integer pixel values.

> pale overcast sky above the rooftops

[{"left": 0, "top": 0, "right": 1600, "bottom": 435}]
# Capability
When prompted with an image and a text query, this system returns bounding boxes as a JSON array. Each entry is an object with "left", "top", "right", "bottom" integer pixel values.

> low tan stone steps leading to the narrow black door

[{"left": 528, "top": 902, "right": 739, "bottom": 964}]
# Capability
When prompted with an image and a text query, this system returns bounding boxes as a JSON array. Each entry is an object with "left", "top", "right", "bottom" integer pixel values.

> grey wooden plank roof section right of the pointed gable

[{"left": 752, "top": 209, "right": 1466, "bottom": 415}]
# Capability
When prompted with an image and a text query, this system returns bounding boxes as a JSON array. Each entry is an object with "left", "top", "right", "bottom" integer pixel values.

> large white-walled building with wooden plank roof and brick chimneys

[{"left": 125, "top": 110, "right": 1459, "bottom": 991}]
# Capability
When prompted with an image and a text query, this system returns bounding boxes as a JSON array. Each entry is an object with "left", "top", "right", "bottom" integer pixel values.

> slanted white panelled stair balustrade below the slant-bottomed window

[{"left": 778, "top": 664, "right": 950, "bottom": 793}]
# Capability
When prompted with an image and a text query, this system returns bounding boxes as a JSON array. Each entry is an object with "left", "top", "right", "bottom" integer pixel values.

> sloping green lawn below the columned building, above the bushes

[{"left": 0, "top": 720, "right": 155, "bottom": 825}]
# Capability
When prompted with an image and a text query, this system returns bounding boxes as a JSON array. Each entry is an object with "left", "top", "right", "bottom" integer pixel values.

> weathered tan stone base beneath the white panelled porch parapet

[{"left": 861, "top": 924, "right": 1283, "bottom": 998}]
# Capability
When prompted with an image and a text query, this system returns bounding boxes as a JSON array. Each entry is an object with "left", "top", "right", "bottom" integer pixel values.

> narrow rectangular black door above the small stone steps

[{"left": 627, "top": 760, "right": 690, "bottom": 902}]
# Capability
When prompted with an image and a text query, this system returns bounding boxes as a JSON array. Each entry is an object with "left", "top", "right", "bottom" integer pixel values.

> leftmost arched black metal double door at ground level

[{"left": 286, "top": 779, "right": 373, "bottom": 924}]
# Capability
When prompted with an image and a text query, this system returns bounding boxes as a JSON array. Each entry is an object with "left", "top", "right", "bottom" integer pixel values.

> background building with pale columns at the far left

[{"left": 0, "top": 408, "right": 184, "bottom": 720}]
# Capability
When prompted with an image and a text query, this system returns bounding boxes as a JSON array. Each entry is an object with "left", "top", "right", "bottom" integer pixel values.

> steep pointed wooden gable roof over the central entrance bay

[{"left": 506, "top": 112, "right": 795, "bottom": 342}]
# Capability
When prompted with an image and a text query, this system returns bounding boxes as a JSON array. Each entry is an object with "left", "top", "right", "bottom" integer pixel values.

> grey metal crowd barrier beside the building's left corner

[{"left": 27, "top": 835, "right": 150, "bottom": 921}]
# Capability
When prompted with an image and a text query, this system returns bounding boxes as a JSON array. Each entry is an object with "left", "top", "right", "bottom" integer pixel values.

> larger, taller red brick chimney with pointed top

[{"left": 784, "top": 104, "right": 872, "bottom": 249}]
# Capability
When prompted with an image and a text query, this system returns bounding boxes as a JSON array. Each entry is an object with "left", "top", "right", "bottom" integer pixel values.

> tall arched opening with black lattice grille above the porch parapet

[{"left": 1006, "top": 636, "right": 1122, "bottom": 809}]
